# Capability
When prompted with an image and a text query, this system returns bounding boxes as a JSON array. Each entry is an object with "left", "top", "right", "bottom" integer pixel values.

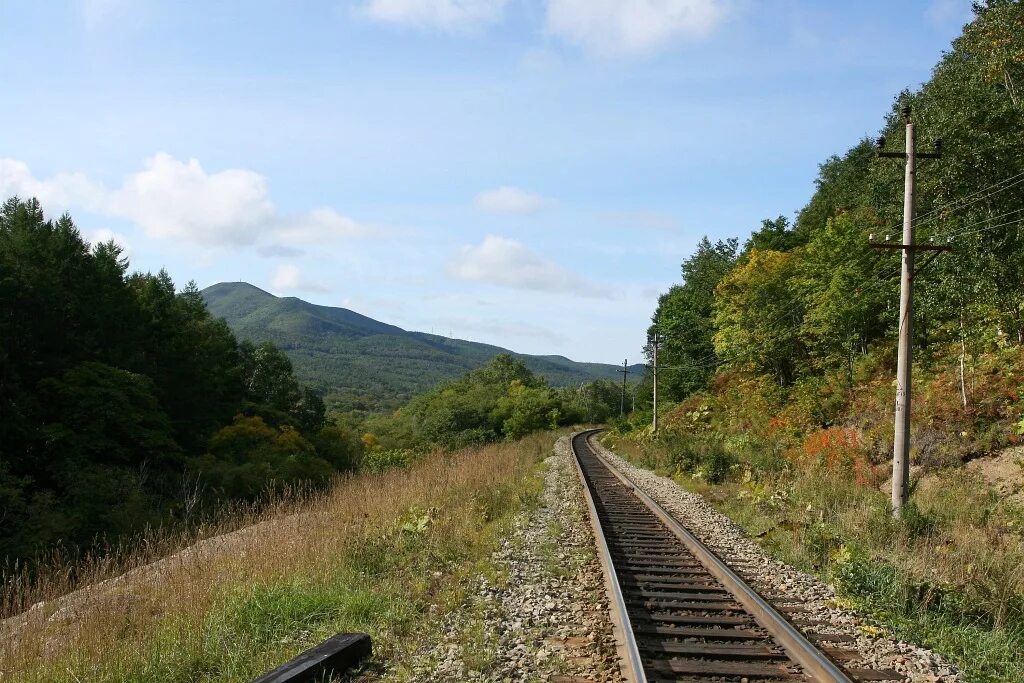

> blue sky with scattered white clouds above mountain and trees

[{"left": 0, "top": 0, "right": 971, "bottom": 362}]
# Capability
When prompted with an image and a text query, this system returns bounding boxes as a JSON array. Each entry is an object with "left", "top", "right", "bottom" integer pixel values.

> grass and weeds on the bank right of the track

[{"left": 606, "top": 435, "right": 1024, "bottom": 683}]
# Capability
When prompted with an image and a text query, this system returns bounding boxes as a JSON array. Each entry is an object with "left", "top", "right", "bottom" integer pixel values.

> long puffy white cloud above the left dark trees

[{"left": 0, "top": 153, "right": 382, "bottom": 249}]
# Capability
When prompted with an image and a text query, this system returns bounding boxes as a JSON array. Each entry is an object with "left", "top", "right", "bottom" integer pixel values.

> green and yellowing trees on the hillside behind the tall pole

[{"left": 649, "top": 0, "right": 1024, "bottom": 454}]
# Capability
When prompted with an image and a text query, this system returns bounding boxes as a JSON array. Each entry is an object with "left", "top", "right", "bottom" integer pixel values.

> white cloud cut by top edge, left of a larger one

[{"left": 361, "top": 0, "right": 508, "bottom": 31}]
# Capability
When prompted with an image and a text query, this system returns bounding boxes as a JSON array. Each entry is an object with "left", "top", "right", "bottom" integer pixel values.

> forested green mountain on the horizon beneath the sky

[{"left": 203, "top": 283, "right": 643, "bottom": 410}]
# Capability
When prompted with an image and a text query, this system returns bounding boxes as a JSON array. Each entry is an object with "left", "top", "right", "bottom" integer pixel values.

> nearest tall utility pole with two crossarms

[{"left": 869, "top": 104, "right": 949, "bottom": 517}]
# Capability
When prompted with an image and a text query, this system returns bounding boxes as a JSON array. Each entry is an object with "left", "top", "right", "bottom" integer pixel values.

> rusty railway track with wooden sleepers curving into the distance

[{"left": 572, "top": 430, "right": 903, "bottom": 683}]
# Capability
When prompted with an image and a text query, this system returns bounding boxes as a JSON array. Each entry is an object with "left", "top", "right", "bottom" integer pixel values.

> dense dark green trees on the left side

[{"left": 0, "top": 198, "right": 362, "bottom": 561}]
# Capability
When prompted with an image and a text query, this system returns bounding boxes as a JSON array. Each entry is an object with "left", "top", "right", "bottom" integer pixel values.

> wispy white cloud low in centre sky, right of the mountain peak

[{"left": 449, "top": 234, "right": 610, "bottom": 297}]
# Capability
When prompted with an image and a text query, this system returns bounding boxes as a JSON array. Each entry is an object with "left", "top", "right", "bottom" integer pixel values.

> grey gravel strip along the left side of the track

[{"left": 384, "top": 437, "right": 622, "bottom": 683}]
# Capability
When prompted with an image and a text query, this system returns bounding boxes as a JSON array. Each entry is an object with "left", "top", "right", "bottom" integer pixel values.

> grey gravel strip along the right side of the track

[{"left": 591, "top": 439, "right": 964, "bottom": 683}]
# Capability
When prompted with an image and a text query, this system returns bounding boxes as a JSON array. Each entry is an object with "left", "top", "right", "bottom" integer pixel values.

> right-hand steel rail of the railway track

[{"left": 585, "top": 429, "right": 854, "bottom": 683}]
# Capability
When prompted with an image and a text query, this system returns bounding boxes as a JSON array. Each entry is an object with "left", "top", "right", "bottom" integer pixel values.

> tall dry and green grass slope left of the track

[{"left": 0, "top": 433, "right": 554, "bottom": 683}]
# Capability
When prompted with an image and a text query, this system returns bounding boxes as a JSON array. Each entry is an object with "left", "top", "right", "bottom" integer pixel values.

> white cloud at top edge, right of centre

[{"left": 547, "top": 0, "right": 725, "bottom": 55}]
